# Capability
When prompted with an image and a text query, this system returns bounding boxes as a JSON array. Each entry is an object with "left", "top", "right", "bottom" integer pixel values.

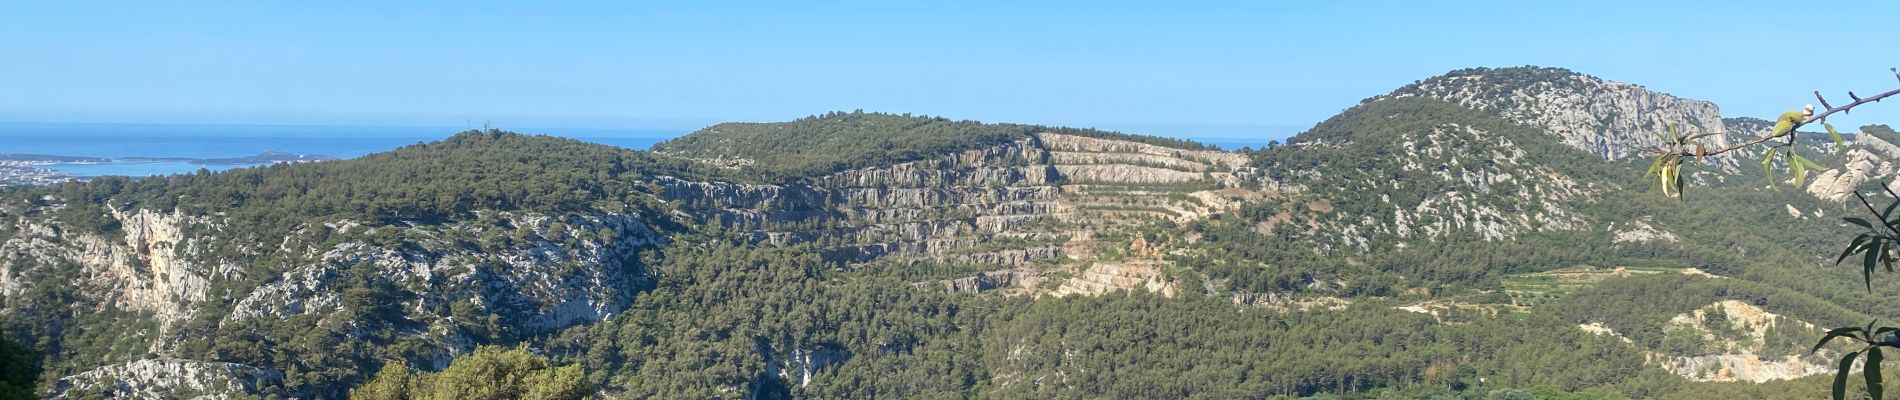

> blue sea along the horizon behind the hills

[{"left": 0, "top": 121, "right": 1265, "bottom": 178}]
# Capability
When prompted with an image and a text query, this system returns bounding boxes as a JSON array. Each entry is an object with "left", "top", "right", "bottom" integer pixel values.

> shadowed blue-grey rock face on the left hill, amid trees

[{"left": 228, "top": 212, "right": 665, "bottom": 334}]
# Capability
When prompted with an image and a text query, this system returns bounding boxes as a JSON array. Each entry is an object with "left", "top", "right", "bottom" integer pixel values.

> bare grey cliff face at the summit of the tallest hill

[{"left": 1391, "top": 68, "right": 1731, "bottom": 159}]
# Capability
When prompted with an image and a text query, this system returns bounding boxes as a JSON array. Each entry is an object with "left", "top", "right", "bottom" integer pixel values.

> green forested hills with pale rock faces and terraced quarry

[{"left": 0, "top": 68, "right": 1900, "bottom": 398}]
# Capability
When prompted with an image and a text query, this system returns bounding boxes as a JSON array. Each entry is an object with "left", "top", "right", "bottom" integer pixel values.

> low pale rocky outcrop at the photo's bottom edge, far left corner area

[{"left": 46, "top": 358, "right": 283, "bottom": 400}]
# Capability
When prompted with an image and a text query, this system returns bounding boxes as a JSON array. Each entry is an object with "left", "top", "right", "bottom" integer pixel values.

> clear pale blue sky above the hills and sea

[{"left": 0, "top": 2, "right": 1900, "bottom": 136}]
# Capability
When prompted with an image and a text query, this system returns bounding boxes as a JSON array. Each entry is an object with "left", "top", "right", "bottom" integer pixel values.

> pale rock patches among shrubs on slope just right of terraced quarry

[{"left": 1292, "top": 123, "right": 1604, "bottom": 252}]
